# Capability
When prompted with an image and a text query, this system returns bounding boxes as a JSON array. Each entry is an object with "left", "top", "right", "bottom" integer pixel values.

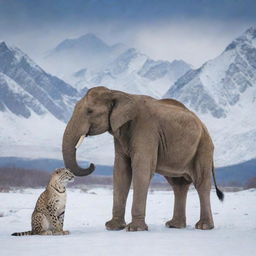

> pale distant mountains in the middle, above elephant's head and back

[{"left": 45, "top": 33, "right": 191, "bottom": 98}]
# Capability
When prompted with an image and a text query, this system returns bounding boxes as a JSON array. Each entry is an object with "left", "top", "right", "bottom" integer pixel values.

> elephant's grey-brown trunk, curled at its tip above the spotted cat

[{"left": 62, "top": 120, "right": 95, "bottom": 176}]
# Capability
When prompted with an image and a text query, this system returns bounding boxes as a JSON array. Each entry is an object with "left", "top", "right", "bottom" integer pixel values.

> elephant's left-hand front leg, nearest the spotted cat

[{"left": 105, "top": 155, "right": 132, "bottom": 230}]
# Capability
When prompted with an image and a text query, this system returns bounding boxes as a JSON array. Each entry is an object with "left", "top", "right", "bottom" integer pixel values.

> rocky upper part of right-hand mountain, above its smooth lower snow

[{"left": 166, "top": 28, "right": 256, "bottom": 118}]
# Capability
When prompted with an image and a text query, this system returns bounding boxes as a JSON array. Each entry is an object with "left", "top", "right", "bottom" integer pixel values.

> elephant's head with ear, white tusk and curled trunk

[{"left": 62, "top": 87, "right": 135, "bottom": 176}]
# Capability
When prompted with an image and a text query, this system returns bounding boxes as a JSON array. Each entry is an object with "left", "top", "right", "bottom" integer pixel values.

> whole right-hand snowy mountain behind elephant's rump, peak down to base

[{"left": 164, "top": 27, "right": 256, "bottom": 164}]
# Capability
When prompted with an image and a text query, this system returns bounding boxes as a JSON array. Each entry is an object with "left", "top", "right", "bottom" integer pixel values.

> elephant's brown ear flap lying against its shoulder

[{"left": 110, "top": 90, "right": 137, "bottom": 132}]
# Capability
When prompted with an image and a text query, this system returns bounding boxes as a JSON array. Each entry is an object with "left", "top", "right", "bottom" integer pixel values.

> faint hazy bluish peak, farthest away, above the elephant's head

[{"left": 45, "top": 33, "right": 127, "bottom": 80}]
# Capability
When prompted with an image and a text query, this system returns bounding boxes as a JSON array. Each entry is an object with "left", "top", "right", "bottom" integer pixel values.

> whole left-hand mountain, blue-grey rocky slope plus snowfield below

[{"left": 0, "top": 42, "right": 84, "bottom": 162}]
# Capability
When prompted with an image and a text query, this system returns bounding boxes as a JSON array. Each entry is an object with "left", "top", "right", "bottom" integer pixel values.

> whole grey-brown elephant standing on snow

[{"left": 62, "top": 86, "right": 224, "bottom": 231}]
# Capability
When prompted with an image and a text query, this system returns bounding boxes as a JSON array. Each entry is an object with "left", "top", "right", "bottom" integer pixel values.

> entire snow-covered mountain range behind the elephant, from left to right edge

[{"left": 0, "top": 27, "right": 256, "bottom": 172}]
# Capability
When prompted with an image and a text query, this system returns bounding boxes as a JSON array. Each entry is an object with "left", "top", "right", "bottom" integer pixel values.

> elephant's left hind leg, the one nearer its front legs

[{"left": 165, "top": 177, "right": 191, "bottom": 228}]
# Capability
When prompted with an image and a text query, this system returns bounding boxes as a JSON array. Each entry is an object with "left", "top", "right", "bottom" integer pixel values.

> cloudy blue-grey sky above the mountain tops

[{"left": 0, "top": 0, "right": 256, "bottom": 67}]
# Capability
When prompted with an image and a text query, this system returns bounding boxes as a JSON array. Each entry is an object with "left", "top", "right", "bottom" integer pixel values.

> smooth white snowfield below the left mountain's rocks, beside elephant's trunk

[{"left": 0, "top": 110, "right": 66, "bottom": 159}]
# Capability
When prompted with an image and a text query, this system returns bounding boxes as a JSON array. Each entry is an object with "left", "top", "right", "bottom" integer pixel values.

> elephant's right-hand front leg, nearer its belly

[{"left": 126, "top": 155, "right": 152, "bottom": 231}]
